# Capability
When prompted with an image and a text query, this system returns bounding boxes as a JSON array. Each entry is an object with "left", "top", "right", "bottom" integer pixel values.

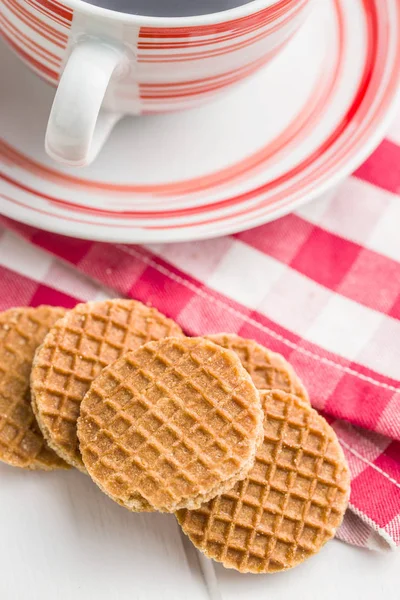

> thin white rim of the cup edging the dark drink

[{"left": 62, "top": 0, "right": 284, "bottom": 27}]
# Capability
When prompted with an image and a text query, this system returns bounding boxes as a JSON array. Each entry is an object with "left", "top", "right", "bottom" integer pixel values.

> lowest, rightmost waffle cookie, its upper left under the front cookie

[{"left": 177, "top": 390, "right": 350, "bottom": 573}]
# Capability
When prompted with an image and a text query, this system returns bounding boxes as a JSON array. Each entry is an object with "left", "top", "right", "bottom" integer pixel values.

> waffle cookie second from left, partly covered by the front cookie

[{"left": 31, "top": 300, "right": 183, "bottom": 471}]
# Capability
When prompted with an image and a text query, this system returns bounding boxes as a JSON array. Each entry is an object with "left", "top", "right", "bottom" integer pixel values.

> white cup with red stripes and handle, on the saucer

[{"left": 0, "top": 0, "right": 311, "bottom": 166}]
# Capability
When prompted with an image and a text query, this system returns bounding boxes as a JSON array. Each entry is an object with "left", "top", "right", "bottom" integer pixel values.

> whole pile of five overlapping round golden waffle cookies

[{"left": 0, "top": 300, "right": 350, "bottom": 573}]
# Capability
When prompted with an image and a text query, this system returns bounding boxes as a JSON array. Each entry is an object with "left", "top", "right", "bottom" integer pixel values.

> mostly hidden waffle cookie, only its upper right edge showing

[{"left": 207, "top": 333, "right": 310, "bottom": 403}]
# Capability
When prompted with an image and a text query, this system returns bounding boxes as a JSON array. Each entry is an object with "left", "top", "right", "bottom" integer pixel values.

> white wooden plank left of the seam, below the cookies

[{"left": 0, "top": 465, "right": 209, "bottom": 600}]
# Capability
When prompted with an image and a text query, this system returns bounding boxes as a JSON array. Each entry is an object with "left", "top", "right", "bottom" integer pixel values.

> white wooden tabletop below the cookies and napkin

[{"left": 0, "top": 465, "right": 400, "bottom": 600}]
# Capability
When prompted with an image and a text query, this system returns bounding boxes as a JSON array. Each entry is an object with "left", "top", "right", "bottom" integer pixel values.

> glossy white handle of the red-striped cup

[{"left": 45, "top": 40, "right": 125, "bottom": 167}]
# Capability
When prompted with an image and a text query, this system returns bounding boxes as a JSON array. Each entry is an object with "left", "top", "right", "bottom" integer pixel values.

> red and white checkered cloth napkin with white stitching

[{"left": 0, "top": 112, "right": 400, "bottom": 549}]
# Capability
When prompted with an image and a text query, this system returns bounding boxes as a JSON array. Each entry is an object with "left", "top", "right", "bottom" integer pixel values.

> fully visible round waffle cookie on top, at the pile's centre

[{"left": 78, "top": 338, "right": 263, "bottom": 512}]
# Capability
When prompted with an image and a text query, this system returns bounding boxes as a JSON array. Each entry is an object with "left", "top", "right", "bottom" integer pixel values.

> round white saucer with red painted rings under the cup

[{"left": 0, "top": 0, "right": 400, "bottom": 243}]
